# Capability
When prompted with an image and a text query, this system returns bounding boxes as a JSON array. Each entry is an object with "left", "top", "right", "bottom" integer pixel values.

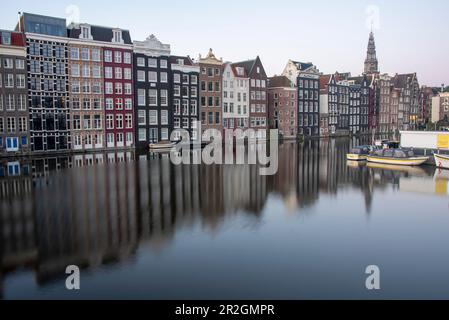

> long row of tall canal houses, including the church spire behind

[{"left": 0, "top": 13, "right": 419, "bottom": 155}]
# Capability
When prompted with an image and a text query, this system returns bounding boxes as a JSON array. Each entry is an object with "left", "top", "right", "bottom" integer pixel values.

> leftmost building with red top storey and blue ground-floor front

[{"left": 0, "top": 30, "right": 30, "bottom": 155}]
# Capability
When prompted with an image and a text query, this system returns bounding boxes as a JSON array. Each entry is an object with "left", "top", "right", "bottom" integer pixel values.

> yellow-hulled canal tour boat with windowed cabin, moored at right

[{"left": 367, "top": 149, "right": 429, "bottom": 166}]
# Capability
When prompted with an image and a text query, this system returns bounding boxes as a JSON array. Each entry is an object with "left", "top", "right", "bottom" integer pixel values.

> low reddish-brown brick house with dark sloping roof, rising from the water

[{"left": 268, "top": 76, "right": 298, "bottom": 139}]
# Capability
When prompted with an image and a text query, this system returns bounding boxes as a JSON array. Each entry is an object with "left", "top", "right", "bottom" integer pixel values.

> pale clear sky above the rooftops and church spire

[{"left": 0, "top": 0, "right": 449, "bottom": 86}]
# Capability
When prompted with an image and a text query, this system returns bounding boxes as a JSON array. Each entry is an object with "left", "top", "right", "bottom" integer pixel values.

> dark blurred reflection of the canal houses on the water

[{"left": 0, "top": 139, "right": 440, "bottom": 298}]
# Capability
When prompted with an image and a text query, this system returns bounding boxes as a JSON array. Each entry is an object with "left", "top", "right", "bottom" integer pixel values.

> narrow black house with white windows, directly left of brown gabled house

[{"left": 170, "top": 56, "right": 201, "bottom": 141}]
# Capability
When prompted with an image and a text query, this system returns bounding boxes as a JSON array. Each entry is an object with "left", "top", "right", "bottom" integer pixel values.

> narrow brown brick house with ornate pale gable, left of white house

[{"left": 198, "top": 49, "right": 224, "bottom": 132}]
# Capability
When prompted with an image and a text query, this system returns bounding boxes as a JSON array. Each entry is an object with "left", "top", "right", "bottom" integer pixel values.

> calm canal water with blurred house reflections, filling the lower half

[{"left": 0, "top": 139, "right": 449, "bottom": 299}]
